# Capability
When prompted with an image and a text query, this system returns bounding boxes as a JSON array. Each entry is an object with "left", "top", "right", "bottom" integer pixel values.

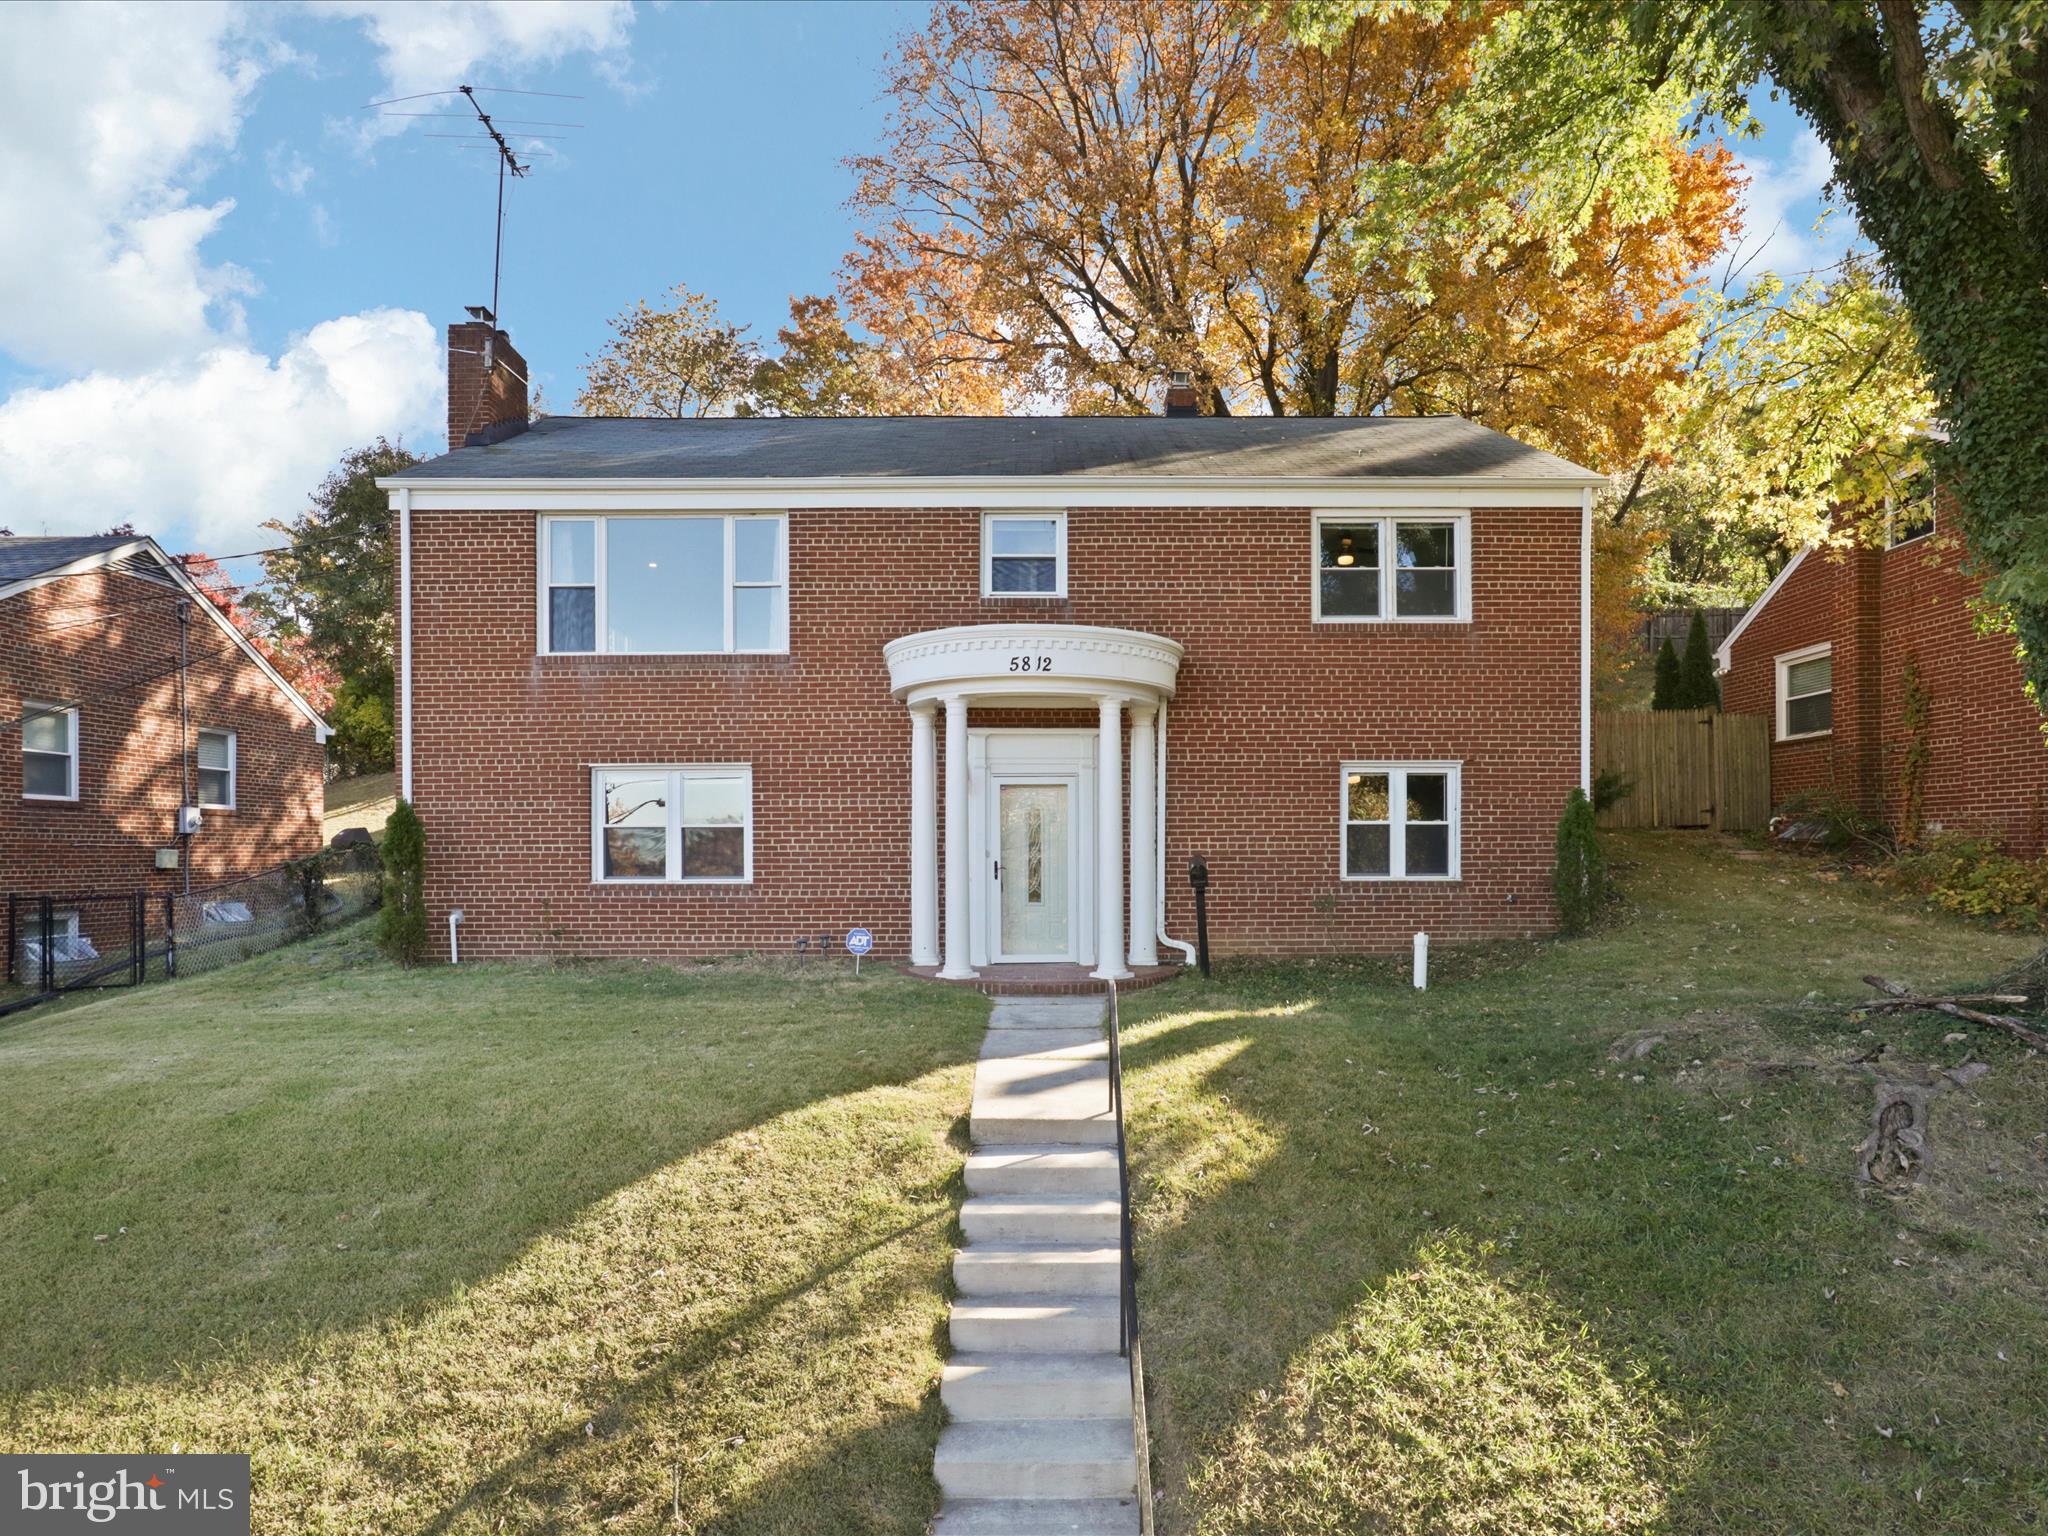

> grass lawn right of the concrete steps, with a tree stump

[{"left": 1124, "top": 836, "right": 2048, "bottom": 1536}]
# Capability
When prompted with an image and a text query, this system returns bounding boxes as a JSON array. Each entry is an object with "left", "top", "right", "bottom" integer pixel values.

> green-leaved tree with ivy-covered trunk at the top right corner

[{"left": 1288, "top": 0, "right": 2048, "bottom": 700}]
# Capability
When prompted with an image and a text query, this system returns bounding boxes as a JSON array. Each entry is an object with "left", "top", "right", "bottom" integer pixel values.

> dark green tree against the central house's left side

[{"left": 244, "top": 438, "right": 420, "bottom": 774}]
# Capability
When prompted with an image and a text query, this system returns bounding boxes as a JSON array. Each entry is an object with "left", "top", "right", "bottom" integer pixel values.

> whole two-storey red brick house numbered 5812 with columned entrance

[{"left": 381, "top": 326, "right": 1599, "bottom": 975}]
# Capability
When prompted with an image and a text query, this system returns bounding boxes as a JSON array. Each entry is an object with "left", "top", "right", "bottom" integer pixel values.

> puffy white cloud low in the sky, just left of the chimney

[{"left": 0, "top": 309, "right": 442, "bottom": 553}]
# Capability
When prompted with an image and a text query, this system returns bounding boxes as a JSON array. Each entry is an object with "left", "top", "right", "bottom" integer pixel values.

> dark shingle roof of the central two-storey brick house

[{"left": 389, "top": 416, "right": 1593, "bottom": 485}]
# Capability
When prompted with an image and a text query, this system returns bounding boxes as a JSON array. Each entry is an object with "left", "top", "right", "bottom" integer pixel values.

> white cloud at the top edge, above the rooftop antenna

[{"left": 313, "top": 0, "right": 633, "bottom": 139}]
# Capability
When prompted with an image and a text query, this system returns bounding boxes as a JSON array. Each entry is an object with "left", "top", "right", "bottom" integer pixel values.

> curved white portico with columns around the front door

[{"left": 883, "top": 623, "right": 1182, "bottom": 981}]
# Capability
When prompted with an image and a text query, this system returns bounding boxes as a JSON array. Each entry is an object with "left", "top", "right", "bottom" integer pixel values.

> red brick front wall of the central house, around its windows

[{"left": 412, "top": 508, "right": 1579, "bottom": 954}]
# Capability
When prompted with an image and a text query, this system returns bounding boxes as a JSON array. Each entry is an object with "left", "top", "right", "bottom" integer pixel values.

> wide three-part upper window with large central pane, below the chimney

[{"left": 541, "top": 512, "right": 788, "bottom": 655}]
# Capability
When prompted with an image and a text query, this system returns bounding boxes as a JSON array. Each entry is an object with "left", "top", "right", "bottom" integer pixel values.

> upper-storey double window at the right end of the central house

[{"left": 1315, "top": 512, "right": 1473, "bottom": 625}]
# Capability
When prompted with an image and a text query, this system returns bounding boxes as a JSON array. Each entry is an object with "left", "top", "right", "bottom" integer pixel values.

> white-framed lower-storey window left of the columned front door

[{"left": 590, "top": 764, "right": 754, "bottom": 885}]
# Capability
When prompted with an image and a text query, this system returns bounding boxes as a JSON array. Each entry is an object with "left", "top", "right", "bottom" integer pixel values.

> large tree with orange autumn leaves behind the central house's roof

[{"left": 842, "top": 0, "right": 1737, "bottom": 469}]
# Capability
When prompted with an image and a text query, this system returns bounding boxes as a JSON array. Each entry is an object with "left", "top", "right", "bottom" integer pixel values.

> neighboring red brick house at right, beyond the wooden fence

[{"left": 1718, "top": 502, "right": 2048, "bottom": 854}]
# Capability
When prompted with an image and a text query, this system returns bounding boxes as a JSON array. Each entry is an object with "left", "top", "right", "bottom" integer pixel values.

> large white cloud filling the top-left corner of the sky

[{"left": 0, "top": 6, "right": 262, "bottom": 373}]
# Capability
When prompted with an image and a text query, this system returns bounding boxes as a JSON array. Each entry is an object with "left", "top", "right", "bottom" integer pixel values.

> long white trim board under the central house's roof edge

[{"left": 377, "top": 475, "right": 1608, "bottom": 512}]
